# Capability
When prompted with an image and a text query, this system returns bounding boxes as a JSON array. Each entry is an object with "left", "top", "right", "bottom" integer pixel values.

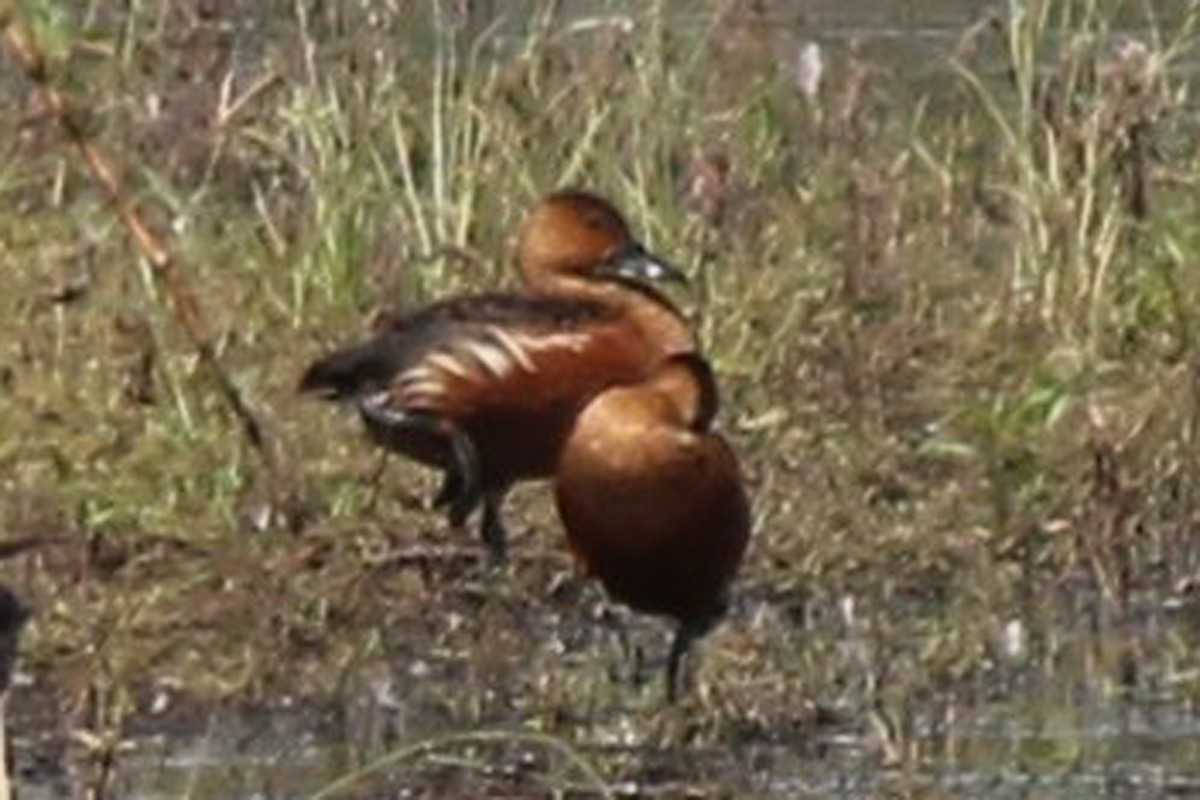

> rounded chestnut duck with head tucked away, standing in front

[{"left": 556, "top": 353, "right": 750, "bottom": 700}]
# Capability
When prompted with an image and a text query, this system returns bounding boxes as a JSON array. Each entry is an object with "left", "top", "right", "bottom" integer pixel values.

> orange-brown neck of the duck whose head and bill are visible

[{"left": 529, "top": 277, "right": 696, "bottom": 356}]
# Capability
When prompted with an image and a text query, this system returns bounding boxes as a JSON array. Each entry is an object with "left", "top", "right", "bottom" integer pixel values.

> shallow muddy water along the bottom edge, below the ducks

[{"left": 14, "top": 606, "right": 1200, "bottom": 800}]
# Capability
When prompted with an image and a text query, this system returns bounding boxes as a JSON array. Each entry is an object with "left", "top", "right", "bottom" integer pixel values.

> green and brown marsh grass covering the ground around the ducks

[{"left": 0, "top": 0, "right": 1200, "bottom": 790}]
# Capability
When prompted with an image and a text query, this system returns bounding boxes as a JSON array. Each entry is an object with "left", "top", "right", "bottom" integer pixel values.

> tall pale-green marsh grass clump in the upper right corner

[{"left": 953, "top": 2, "right": 1195, "bottom": 348}]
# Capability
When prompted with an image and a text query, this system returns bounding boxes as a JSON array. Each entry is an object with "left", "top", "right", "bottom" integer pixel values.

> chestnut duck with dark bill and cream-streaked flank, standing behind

[{"left": 300, "top": 191, "right": 695, "bottom": 558}]
